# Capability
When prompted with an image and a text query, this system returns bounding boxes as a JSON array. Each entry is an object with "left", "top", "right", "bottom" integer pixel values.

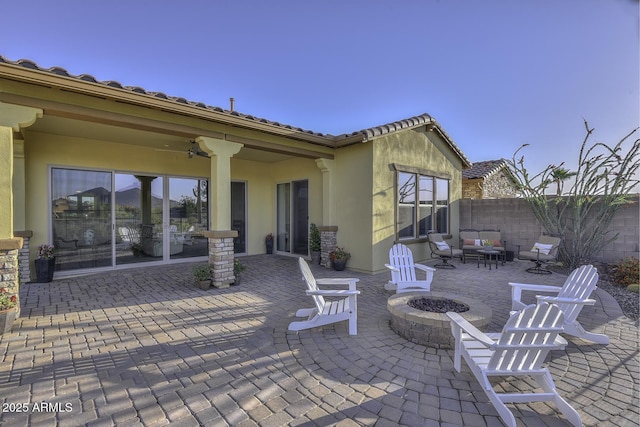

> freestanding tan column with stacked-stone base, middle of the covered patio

[{"left": 196, "top": 136, "right": 243, "bottom": 288}]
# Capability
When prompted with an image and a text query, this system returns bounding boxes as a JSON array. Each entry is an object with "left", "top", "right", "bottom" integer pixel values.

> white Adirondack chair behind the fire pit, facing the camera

[{"left": 384, "top": 243, "right": 436, "bottom": 293}]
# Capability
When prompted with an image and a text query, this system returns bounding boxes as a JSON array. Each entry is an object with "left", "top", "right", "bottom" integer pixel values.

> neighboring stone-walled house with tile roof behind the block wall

[{"left": 462, "top": 159, "right": 518, "bottom": 200}]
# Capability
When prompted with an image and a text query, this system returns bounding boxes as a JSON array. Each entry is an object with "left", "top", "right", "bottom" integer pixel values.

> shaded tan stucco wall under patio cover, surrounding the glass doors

[{"left": 24, "top": 133, "right": 322, "bottom": 257}]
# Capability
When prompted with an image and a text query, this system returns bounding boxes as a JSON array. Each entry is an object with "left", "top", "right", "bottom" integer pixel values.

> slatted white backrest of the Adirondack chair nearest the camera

[{"left": 487, "top": 302, "right": 564, "bottom": 372}]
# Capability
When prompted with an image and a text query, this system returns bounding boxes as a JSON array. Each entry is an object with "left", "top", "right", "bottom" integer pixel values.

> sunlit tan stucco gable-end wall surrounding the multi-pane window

[{"left": 372, "top": 128, "right": 462, "bottom": 271}]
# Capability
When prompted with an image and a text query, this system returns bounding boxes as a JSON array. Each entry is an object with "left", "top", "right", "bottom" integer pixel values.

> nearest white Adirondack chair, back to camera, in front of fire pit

[{"left": 447, "top": 302, "right": 582, "bottom": 427}]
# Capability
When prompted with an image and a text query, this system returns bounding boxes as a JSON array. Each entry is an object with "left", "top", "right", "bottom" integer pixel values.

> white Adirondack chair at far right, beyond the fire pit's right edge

[{"left": 509, "top": 265, "right": 609, "bottom": 344}]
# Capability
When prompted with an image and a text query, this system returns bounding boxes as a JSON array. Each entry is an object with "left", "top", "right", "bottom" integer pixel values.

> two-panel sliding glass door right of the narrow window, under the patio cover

[{"left": 276, "top": 180, "right": 309, "bottom": 255}]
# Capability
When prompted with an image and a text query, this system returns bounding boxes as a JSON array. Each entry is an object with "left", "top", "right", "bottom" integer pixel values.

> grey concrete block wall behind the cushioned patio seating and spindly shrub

[{"left": 460, "top": 195, "right": 640, "bottom": 264}]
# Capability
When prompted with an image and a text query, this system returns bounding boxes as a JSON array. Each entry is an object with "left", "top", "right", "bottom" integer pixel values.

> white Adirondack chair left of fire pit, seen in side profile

[{"left": 289, "top": 258, "right": 360, "bottom": 335}]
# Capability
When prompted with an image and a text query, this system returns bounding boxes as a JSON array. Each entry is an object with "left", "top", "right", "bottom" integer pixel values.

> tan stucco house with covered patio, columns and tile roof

[{"left": 0, "top": 57, "right": 471, "bottom": 288}]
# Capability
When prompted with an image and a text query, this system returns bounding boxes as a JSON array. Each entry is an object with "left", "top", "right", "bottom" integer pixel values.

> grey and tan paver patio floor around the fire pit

[{"left": 0, "top": 255, "right": 640, "bottom": 426}]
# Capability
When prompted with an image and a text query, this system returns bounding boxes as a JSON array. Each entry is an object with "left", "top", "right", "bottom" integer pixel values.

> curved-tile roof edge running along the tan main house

[{"left": 0, "top": 55, "right": 471, "bottom": 167}]
